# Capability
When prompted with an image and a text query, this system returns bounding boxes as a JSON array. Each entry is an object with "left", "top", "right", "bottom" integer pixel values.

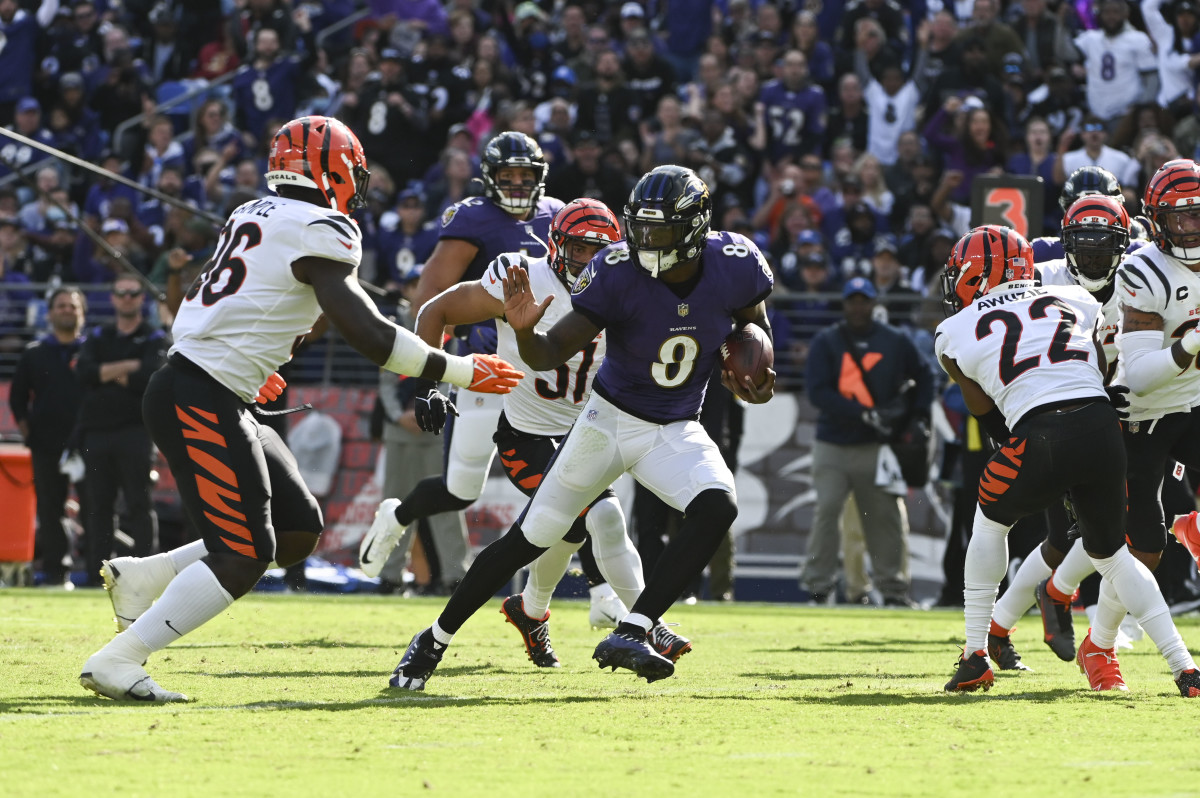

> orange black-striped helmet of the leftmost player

[{"left": 266, "top": 116, "right": 371, "bottom": 214}]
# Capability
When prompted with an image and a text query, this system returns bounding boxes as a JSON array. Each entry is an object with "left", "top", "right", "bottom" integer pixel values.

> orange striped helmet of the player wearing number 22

[{"left": 942, "top": 224, "right": 1034, "bottom": 316}]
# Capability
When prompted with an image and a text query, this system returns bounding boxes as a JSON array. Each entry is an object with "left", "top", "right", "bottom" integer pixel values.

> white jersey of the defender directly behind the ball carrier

[{"left": 479, "top": 258, "right": 605, "bottom": 437}]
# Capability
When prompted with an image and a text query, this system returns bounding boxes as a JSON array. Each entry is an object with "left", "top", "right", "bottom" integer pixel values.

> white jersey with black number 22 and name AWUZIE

[{"left": 934, "top": 283, "right": 1105, "bottom": 428}]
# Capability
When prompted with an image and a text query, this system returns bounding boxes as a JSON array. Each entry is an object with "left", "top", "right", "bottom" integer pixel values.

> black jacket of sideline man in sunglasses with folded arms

[{"left": 76, "top": 322, "right": 170, "bottom": 431}]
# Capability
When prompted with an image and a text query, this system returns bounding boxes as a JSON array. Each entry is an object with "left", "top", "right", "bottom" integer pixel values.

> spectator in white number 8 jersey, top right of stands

[{"left": 1075, "top": 0, "right": 1158, "bottom": 125}]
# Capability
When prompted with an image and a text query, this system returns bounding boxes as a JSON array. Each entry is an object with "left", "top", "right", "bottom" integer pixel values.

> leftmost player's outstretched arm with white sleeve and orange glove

[{"left": 292, "top": 258, "right": 524, "bottom": 394}]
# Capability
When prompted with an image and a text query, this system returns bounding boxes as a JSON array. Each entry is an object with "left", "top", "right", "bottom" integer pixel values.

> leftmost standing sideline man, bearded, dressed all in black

[{"left": 8, "top": 283, "right": 88, "bottom": 586}]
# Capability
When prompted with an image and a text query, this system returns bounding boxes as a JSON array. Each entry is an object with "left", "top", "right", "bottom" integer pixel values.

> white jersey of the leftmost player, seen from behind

[{"left": 170, "top": 197, "right": 362, "bottom": 402}]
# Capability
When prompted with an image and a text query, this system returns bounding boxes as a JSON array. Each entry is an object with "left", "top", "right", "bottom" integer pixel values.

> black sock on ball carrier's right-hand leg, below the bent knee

[{"left": 630, "top": 488, "right": 738, "bottom": 618}]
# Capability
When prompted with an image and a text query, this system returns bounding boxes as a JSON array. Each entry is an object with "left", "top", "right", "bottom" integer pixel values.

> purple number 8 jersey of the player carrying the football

[{"left": 571, "top": 233, "right": 774, "bottom": 424}]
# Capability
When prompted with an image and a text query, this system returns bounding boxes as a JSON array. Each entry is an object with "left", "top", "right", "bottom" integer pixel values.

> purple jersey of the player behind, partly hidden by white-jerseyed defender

[{"left": 438, "top": 197, "right": 563, "bottom": 355}]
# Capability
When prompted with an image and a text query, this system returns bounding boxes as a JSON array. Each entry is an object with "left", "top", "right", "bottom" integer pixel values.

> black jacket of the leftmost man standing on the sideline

[{"left": 8, "top": 335, "right": 83, "bottom": 451}]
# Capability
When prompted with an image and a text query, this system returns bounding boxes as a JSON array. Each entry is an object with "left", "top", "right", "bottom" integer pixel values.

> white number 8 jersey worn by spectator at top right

[{"left": 1063, "top": 23, "right": 1158, "bottom": 120}]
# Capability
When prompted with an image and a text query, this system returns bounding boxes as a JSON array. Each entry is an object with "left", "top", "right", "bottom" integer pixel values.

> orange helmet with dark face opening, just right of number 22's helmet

[{"left": 1062, "top": 194, "right": 1129, "bottom": 294}]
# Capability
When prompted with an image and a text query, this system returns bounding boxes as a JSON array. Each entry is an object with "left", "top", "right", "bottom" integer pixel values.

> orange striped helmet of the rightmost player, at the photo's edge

[{"left": 1141, "top": 158, "right": 1200, "bottom": 265}]
